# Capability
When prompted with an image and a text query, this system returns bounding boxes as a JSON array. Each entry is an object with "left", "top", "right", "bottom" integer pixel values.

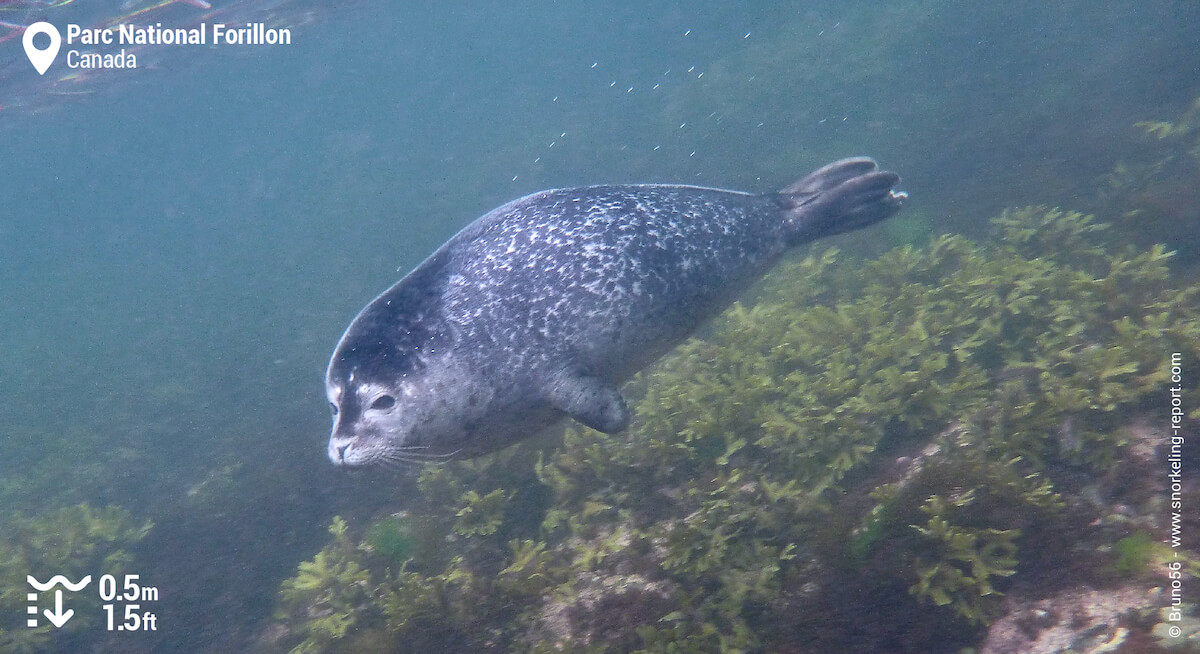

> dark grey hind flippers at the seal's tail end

[{"left": 778, "top": 157, "right": 908, "bottom": 245}]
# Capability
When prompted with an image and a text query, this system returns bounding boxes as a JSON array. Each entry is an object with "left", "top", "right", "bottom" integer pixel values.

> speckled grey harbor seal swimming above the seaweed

[{"left": 325, "top": 157, "right": 906, "bottom": 466}]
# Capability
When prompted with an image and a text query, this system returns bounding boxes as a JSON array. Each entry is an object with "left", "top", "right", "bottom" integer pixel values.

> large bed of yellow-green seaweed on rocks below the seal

[{"left": 270, "top": 202, "right": 1200, "bottom": 653}]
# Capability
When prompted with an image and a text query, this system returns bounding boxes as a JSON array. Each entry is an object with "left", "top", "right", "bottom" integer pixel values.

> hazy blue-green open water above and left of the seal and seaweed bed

[{"left": 0, "top": 0, "right": 1200, "bottom": 652}]
